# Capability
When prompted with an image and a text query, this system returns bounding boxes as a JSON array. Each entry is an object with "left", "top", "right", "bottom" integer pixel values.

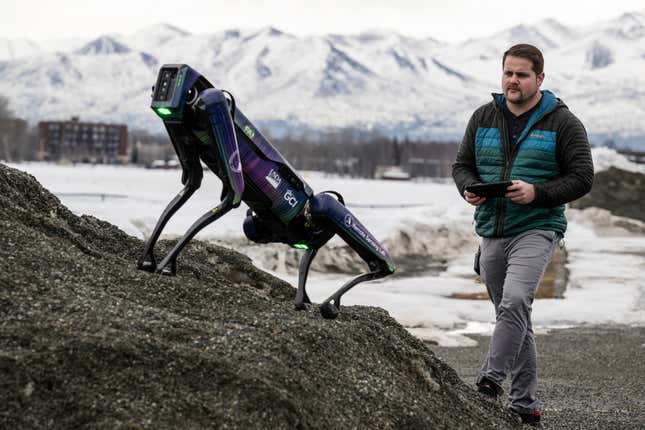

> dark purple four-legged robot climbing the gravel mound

[{"left": 137, "top": 64, "right": 395, "bottom": 319}]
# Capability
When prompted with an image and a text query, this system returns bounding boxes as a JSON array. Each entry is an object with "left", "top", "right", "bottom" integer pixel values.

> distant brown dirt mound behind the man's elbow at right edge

[{"left": 571, "top": 167, "right": 645, "bottom": 222}]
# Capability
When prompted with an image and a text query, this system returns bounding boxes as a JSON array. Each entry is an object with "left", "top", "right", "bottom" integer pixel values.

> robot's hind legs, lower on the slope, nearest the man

[{"left": 304, "top": 193, "right": 396, "bottom": 319}]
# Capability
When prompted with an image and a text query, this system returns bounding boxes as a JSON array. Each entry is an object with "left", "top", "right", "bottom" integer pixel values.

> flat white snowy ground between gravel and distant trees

[{"left": 6, "top": 150, "right": 645, "bottom": 345}]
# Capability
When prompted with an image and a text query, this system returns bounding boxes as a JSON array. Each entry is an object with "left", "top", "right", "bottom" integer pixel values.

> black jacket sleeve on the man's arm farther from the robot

[{"left": 532, "top": 112, "right": 594, "bottom": 207}]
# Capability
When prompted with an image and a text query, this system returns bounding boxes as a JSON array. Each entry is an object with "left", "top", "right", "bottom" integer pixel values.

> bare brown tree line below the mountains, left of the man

[{"left": 0, "top": 96, "right": 457, "bottom": 178}]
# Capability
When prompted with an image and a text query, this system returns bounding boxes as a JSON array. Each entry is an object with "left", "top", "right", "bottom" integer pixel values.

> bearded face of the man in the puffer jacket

[{"left": 502, "top": 55, "right": 544, "bottom": 105}]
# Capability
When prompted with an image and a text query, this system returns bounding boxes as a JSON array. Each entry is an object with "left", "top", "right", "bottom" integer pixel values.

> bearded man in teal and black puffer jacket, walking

[{"left": 452, "top": 44, "right": 593, "bottom": 427}]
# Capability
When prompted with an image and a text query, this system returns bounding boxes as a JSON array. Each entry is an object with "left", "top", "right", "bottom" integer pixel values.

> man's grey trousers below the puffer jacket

[{"left": 476, "top": 230, "right": 560, "bottom": 413}]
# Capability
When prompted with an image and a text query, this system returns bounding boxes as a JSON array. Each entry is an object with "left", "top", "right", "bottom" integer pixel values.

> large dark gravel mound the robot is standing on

[{"left": 0, "top": 165, "right": 513, "bottom": 429}]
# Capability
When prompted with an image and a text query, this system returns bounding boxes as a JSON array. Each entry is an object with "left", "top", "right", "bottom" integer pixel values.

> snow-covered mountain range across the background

[{"left": 0, "top": 11, "right": 645, "bottom": 149}]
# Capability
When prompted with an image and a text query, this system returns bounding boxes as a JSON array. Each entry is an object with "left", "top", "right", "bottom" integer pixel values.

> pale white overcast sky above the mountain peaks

[{"left": 5, "top": 0, "right": 645, "bottom": 42}]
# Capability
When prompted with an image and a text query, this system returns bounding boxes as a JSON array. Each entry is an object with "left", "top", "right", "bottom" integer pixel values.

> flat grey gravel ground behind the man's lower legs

[{"left": 430, "top": 325, "right": 645, "bottom": 430}]
